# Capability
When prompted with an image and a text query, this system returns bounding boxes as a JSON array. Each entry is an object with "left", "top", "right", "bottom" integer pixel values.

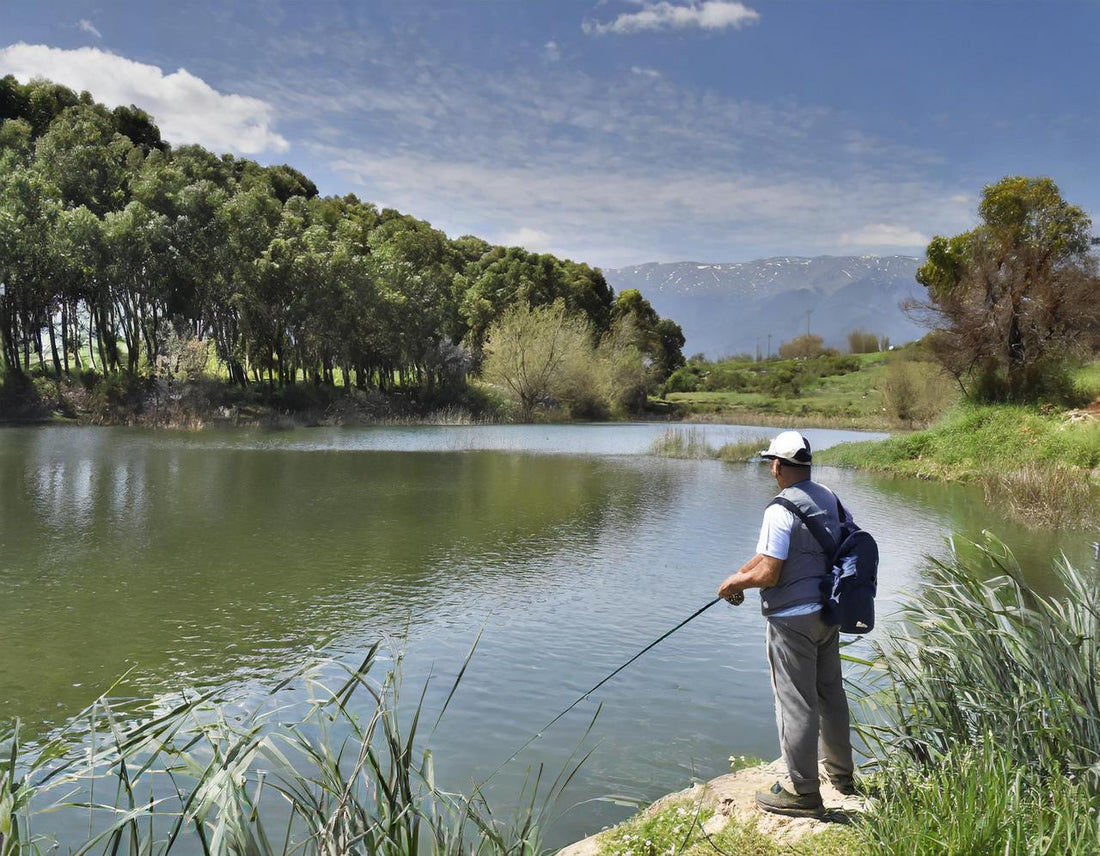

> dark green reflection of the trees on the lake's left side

[{"left": 0, "top": 430, "right": 677, "bottom": 726}]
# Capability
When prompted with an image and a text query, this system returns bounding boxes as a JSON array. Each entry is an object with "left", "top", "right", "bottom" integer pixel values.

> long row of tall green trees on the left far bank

[{"left": 0, "top": 77, "right": 683, "bottom": 407}]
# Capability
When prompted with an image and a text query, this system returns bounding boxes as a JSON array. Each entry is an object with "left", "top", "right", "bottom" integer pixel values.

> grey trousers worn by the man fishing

[{"left": 767, "top": 612, "right": 854, "bottom": 793}]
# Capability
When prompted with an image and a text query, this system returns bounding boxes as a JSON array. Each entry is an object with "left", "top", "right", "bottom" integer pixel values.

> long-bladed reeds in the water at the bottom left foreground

[{"left": 0, "top": 646, "right": 575, "bottom": 856}]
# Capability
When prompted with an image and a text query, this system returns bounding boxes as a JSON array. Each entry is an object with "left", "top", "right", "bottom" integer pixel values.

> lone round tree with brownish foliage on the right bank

[{"left": 910, "top": 176, "right": 1100, "bottom": 400}]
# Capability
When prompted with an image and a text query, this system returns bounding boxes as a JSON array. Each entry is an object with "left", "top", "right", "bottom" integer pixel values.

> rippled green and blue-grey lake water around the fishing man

[{"left": 0, "top": 425, "right": 1096, "bottom": 844}]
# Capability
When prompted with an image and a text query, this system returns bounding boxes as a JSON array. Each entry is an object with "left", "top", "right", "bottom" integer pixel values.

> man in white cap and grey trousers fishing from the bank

[{"left": 718, "top": 431, "right": 856, "bottom": 816}]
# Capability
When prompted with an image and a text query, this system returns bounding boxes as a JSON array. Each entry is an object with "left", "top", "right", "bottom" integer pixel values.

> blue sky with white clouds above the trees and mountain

[{"left": 0, "top": 0, "right": 1100, "bottom": 267}]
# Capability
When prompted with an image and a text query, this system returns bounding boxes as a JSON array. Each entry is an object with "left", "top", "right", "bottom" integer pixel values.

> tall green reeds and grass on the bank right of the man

[{"left": 859, "top": 535, "right": 1100, "bottom": 854}]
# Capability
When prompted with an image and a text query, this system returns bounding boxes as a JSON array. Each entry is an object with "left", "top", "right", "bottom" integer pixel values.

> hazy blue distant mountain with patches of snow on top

[{"left": 604, "top": 255, "right": 926, "bottom": 356}]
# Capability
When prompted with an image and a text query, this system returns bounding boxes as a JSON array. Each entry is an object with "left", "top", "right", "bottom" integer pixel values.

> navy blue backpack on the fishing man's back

[{"left": 770, "top": 496, "right": 879, "bottom": 633}]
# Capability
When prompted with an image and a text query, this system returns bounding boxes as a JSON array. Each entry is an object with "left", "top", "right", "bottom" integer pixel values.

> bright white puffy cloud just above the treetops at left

[{"left": 0, "top": 43, "right": 289, "bottom": 154}]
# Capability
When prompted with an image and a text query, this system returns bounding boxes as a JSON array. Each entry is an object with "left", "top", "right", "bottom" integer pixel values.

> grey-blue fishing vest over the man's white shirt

[{"left": 760, "top": 479, "right": 840, "bottom": 616}]
